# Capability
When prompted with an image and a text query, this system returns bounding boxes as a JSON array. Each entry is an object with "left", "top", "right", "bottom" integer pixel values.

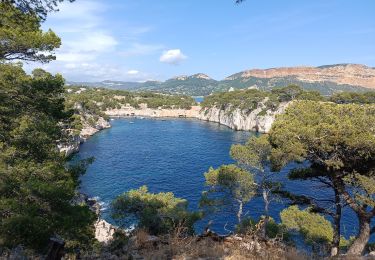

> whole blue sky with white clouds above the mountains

[{"left": 25, "top": 0, "right": 375, "bottom": 82}]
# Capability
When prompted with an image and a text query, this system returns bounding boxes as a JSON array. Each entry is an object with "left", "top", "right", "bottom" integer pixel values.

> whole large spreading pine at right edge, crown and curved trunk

[{"left": 270, "top": 101, "right": 375, "bottom": 255}]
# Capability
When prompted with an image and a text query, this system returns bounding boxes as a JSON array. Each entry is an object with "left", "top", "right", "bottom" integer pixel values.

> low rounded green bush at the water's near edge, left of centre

[{"left": 112, "top": 186, "right": 200, "bottom": 235}]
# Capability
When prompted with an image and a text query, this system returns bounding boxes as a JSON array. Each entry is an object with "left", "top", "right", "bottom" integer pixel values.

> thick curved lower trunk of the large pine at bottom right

[{"left": 348, "top": 214, "right": 371, "bottom": 256}]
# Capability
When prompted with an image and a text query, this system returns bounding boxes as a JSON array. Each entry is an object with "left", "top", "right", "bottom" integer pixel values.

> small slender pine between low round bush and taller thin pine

[{"left": 200, "top": 164, "right": 256, "bottom": 222}]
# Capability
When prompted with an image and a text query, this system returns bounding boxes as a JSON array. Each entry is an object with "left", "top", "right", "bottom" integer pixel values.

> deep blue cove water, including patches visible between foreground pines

[{"left": 74, "top": 118, "right": 356, "bottom": 238}]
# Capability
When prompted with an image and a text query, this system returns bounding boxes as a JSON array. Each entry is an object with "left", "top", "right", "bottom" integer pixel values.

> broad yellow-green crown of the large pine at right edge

[{"left": 270, "top": 101, "right": 375, "bottom": 171}]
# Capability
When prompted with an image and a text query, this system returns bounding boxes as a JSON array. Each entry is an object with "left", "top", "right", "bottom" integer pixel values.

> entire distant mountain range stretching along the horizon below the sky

[{"left": 67, "top": 64, "right": 375, "bottom": 96}]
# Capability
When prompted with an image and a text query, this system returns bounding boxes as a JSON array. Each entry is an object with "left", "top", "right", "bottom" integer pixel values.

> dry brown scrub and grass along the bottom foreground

[{"left": 83, "top": 228, "right": 311, "bottom": 260}]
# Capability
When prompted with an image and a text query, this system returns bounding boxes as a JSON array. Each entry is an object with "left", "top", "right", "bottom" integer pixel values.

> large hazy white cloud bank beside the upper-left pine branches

[{"left": 26, "top": 0, "right": 164, "bottom": 81}]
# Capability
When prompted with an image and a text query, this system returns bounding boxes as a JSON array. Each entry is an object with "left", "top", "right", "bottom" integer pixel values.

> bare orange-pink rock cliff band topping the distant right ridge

[{"left": 226, "top": 64, "right": 375, "bottom": 89}]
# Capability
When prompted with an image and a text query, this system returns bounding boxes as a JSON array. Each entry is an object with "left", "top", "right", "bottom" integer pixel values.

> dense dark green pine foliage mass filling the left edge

[{"left": 0, "top": 64, "right": 95, "bottom": 250}]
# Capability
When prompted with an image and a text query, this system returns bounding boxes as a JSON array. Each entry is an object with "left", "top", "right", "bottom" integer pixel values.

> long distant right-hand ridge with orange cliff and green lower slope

[{"left": 222, "top": 64, "right": 375, "bottom": 95}]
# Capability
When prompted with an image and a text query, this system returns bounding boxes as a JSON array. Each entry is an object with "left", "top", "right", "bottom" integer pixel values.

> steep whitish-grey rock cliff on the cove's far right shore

[{"left": 198, "top": 103, "right": 289, "bottom": 133}]
